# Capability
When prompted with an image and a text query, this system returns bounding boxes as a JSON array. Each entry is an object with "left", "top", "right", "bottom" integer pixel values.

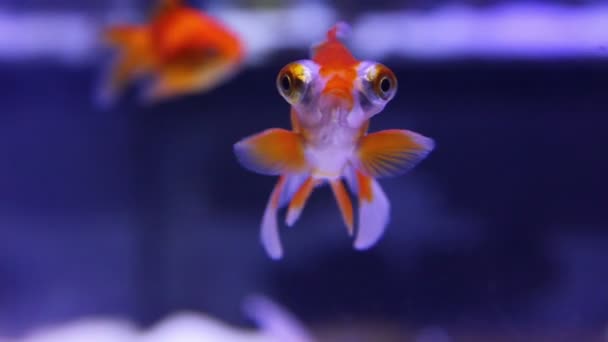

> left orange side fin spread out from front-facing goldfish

[{"left": 234, "top": 128, "right": 307, "bottom": 175}]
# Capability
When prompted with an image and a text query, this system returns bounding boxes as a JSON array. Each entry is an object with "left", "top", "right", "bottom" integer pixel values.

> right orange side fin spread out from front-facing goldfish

[{"left": 355, "top": 129, "right": 435, "bottom": 178}]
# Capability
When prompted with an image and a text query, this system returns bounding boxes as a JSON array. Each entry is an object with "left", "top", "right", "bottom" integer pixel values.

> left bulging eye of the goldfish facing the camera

[{"left": 277, "top": 62, "right": 312, "bottom": 105}]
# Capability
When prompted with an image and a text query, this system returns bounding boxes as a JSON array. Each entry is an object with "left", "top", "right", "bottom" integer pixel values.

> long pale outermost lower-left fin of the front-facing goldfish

[{"left": 260, "top": 176, "right": 287, "bottom": 260}]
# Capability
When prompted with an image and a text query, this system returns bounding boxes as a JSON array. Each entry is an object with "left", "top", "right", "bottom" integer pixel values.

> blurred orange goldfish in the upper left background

[{"left": 99, "top": 0, "right": 245, "bottom": 104}]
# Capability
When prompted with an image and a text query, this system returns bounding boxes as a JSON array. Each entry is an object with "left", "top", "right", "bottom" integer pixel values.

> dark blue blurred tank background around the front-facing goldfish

[{"left": 0, "top": 8, "right": 608, "bottom": 339}]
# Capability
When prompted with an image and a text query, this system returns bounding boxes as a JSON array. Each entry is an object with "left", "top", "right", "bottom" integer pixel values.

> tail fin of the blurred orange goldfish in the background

[{"left": 97, "top": 25, "right": 150, "bottom": 107}]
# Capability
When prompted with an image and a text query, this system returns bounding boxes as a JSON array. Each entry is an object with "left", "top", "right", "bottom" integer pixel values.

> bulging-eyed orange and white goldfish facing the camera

[{"left": 234, "top": 22, "right": 434, "bottom": 259}]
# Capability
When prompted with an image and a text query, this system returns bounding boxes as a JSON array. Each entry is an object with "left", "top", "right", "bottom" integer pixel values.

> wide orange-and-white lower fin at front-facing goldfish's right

[{"left": 355, "top": 172, "right": 390, "bottom": 250}]
